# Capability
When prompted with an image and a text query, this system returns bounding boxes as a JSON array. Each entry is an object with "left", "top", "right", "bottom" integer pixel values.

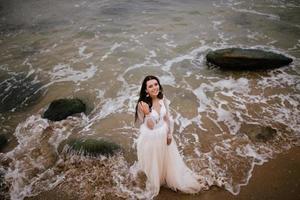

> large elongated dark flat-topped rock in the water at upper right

[{"left": 206, "top": 48, "right": 293, "bottom": 70}]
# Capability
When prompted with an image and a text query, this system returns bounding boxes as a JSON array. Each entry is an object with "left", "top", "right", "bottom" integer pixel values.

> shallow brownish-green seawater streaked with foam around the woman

[{"left": 0, "top": 0, "right": 300, "bottom": 199}]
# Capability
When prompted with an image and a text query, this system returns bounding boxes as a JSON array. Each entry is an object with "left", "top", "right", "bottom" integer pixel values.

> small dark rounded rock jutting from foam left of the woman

[{"left": 43, "top": 99, "right": 86, "bottom": 121}]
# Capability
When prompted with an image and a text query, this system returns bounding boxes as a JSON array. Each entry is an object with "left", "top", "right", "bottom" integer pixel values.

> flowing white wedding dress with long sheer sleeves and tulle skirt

[{"left": 137, "top": 97, "right": 201, "bottom": 198}]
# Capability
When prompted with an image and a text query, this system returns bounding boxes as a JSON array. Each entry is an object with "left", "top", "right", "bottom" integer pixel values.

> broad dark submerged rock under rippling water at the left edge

[{"left": 0, "top": 74, "right": 42, "bottom": 112}]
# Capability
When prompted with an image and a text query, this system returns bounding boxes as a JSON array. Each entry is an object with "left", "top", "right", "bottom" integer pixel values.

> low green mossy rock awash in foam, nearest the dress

[{"left": 67, "top": 138, "right": 121, "bottom": 156}]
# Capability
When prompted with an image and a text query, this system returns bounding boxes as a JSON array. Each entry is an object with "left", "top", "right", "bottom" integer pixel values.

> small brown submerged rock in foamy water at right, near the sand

[{"left": 240, "top": 124, "right": 277, "bottom": 142}]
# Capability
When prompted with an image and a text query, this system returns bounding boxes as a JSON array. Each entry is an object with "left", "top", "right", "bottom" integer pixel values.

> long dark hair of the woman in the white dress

[{"left": 135, "top": 75, "right": 164, "bottom": 122}]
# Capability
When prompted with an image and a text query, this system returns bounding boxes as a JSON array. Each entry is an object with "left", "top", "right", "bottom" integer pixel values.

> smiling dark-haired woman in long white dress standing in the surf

[{"left": 135, "top": 76, "right": 201, "bottom": 197}]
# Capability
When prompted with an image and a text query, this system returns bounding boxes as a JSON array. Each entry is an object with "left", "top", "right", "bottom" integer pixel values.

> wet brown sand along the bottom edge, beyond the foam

[{"left": 26, "top": 147, "right": 300, "bottom": 200}]
